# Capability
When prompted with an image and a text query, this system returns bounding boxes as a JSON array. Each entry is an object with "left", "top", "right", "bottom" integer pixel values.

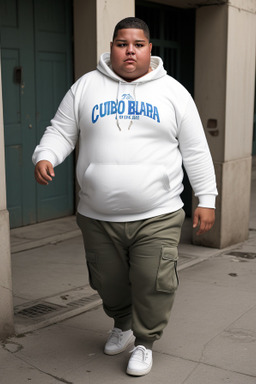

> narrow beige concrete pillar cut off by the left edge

[{"left": 0, "top": 57, "right": 14, "bottom": 339}]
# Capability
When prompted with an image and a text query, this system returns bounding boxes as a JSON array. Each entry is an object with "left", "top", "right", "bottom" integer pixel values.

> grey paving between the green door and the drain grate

[{"left": 12, "top": 236, "right": 88, "bottom": 305}]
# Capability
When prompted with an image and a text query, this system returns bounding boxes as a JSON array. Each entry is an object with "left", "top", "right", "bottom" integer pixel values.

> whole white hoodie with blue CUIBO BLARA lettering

[{"left": 33, "top": 53, "right": 217, "bottom": 222}]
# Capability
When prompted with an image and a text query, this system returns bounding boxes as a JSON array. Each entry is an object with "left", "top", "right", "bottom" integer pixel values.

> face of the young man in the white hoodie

[{"left": 110, "top": 28, "right": 152, "bottom": 81}]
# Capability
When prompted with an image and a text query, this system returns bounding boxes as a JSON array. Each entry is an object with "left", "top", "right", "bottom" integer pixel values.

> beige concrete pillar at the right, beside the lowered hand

[{"left": 193, "top": 0, "right": 256, "bottom": 248}]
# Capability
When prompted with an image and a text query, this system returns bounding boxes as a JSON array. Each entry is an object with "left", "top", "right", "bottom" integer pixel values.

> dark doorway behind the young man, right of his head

[{"left": 135, "top": 1, "right": 195, "bottom": 217}]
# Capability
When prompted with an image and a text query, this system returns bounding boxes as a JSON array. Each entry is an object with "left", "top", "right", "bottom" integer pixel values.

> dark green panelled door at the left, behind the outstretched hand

[{"left": 0, "top": 0, "right": 74, "bottom": 228}]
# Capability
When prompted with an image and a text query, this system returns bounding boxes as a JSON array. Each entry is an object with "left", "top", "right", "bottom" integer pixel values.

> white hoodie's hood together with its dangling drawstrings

[{"left": 97, "top": 53, "right": 166, "bottom": 131}]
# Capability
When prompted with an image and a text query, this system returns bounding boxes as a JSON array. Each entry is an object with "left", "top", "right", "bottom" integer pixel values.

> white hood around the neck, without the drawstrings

[{"left": 97, "top": 53, "right": 166, "bottom": 84}]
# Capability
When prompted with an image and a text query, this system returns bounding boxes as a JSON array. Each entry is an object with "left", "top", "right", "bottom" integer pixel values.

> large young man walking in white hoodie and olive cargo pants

[{"left": 33, "top": 17, "right": 217, "bottom": 376}]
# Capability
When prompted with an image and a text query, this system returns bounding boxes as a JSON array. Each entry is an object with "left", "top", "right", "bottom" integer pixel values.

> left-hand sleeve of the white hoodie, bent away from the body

[{"left": 32, "top": 88, "right": 78, "bottom": 167}]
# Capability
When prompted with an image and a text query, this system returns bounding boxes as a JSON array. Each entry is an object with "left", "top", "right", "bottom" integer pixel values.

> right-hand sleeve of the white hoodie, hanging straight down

[{"left": 178, "top": 96, "right": 218, "bottom": 208}]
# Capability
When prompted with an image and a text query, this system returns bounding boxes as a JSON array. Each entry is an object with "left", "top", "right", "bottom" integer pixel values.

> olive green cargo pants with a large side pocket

[{"left": 77, "top": 209, "right": 185, "bottom": 348}]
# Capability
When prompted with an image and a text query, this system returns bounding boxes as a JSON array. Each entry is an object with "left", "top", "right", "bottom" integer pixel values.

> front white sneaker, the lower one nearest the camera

[{"left": 126, "top": 345, "right": 153, "bottom": 376}]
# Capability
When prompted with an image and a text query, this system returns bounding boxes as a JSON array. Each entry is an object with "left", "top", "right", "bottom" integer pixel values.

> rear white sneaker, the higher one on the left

[{"left": 104, "top": 328, "right": 135, "bottom": 355}]
